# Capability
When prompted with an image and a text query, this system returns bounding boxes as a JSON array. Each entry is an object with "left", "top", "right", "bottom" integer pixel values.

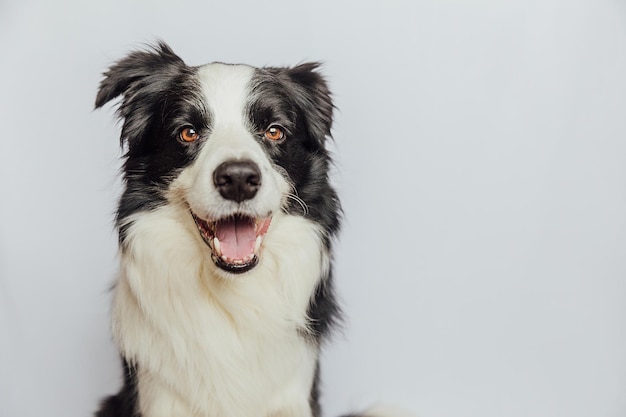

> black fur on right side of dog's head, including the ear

[{"left": 249, "top": 63, "right": 341, "bottom": 244}]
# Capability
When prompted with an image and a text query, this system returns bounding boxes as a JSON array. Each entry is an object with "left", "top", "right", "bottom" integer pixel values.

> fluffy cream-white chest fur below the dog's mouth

[{"left": 113, "top": 205, "right": 328, "bottom": 417}]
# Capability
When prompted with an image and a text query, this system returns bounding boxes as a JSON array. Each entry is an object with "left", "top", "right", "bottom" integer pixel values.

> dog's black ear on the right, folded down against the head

[{"left": 270, "top": 62, "right": 334, "bottom": 146}]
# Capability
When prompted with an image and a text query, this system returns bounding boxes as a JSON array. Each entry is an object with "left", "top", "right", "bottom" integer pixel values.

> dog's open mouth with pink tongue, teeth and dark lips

[{"left": 191, "top": 213, "right": 272, "bottom": 274}]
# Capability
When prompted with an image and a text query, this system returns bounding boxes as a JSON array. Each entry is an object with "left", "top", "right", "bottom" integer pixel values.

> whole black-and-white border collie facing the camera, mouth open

[{"left": 96, "top": 43, "right": 398, "bottom": 417}]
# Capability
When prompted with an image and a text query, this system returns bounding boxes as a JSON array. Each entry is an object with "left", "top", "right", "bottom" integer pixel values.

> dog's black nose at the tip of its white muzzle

[{"left": 213, "top": 161, "right": 261, "bottom": 203}]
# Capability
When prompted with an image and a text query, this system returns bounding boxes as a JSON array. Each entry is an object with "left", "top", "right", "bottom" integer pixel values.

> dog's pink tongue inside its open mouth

[{"left": 215, "top": 217, "right": 256, "bottom": 259}]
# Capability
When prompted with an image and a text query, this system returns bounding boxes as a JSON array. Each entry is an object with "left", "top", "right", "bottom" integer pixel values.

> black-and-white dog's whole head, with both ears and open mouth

[{"left": 96, "top": 44, "right": 339, "bottom": 273}]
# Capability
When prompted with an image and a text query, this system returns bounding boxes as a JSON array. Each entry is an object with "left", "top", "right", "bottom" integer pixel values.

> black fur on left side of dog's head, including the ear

[{"left": 96, "top": 43, "right": 210, "bottom": 243}]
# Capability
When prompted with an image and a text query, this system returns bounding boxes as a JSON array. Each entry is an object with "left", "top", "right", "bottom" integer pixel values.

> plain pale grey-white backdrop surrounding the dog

[{"left": 0, "top": 0, "right": 626, "bottom": 417}]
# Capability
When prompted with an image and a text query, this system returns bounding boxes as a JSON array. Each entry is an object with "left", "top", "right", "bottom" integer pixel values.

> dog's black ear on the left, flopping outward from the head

[{"left": 95, "top": 42, "right": 186, "bottom": 147}]
